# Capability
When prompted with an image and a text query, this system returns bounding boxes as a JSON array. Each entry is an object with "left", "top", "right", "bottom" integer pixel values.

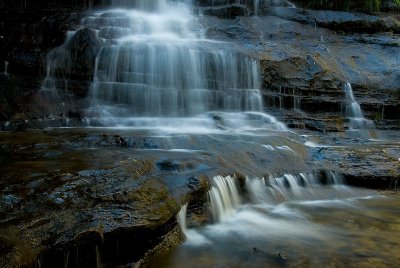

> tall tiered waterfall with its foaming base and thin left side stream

[{"left": 42, "top": 0, "right": 286, "bottom": 133}]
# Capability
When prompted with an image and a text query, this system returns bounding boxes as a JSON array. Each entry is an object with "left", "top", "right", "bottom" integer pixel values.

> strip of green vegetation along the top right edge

[{"left": 297, "top": 0, "right": 400, "bottom": 13}]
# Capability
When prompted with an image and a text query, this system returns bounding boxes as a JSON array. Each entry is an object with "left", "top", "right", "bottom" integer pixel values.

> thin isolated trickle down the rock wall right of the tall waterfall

[{"left": 344, "top": 83, "right": 374, "bottom": 129}]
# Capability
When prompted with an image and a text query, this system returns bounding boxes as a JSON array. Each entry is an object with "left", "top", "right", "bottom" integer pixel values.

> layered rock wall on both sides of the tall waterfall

[{"left": 0, "top": 0, "right": 400, "bottom": 132}]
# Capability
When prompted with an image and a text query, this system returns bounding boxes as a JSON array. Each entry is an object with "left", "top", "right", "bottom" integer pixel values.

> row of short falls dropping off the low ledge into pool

[{"left": 208, "top": 172, "right": 348, "bottom": 222}]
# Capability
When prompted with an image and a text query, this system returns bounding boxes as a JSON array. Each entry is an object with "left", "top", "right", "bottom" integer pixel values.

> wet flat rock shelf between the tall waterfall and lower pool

[{"left": 0, "top": 126, "right": 400, "bottom": 267}]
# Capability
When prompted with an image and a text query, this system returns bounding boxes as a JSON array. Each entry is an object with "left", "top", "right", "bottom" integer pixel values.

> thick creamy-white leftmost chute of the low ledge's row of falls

[{"left": 208, "top": 176, "right": 241, "bottom": 221}]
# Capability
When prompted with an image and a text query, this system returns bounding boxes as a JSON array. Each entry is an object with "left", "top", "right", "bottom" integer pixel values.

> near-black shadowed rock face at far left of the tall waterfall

[{"left": 0, "top": 5, "right": 80, "bottom": 128}]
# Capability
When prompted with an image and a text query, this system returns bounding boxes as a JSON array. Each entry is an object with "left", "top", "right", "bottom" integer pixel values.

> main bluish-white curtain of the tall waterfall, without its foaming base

[{"left": 82, "top": 0, "right": 262, "bottom": 125}]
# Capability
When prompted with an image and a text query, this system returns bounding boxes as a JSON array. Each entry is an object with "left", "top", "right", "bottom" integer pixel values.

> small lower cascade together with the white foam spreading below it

[{"left": 178, "top": 172, "right": 377, "bottom": 254}]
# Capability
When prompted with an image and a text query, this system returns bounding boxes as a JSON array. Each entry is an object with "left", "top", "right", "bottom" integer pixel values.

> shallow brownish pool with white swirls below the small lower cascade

[{"left": 147, "top": 174, "right": 400, "bottom": 267}]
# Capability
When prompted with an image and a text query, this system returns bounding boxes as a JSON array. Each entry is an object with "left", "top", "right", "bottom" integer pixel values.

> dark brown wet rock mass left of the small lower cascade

[{"left": 0, "top": 133, "right": 189, "bottom": 267}]
